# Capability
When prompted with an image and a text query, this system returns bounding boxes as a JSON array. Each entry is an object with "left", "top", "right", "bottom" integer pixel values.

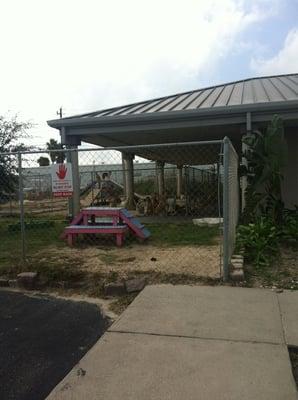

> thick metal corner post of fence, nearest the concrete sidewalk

[{"left": 223, "top": 137, "right": 230, "bottom": 282}]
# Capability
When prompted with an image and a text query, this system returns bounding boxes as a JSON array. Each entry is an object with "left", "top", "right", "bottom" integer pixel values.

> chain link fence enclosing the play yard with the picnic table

[{"left": 0, "top": 141, "right": 239, "bottom": 279}]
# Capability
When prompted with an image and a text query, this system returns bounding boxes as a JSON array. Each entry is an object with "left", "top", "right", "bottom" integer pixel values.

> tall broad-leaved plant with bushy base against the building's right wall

[{"left": 237, "top": 116, "right": 298, "bottom": 267}]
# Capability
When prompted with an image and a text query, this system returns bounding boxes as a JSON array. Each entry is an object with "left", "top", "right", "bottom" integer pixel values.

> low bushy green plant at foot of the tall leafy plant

[{"left": 236, "top": 217, "right": 280, "bottom": 267}]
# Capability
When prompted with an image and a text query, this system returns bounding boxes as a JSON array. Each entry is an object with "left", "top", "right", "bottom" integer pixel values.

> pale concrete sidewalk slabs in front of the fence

[{"left": 48, "top": 285, "right": 298, "bottom": 400}]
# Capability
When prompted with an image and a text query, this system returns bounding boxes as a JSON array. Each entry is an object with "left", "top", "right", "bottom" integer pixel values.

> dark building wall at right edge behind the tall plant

[{"left": 282, "top": 128, "right": 298, "bottom": 208}]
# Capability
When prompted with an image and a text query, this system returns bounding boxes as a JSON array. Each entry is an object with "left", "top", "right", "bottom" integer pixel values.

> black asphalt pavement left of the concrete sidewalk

[{"left": 0, "top": 290, "right": 109, "bottom": 400}]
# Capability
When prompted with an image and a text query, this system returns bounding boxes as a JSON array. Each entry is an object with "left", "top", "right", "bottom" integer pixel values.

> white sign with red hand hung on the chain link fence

[{"left": 51, "top": 163, "right": 73, "bottom": 197}]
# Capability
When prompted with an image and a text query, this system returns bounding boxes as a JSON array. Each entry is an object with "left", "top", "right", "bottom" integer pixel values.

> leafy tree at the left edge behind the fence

[{"left": 0, "top": 115, "right": 32, "bottom": 200}]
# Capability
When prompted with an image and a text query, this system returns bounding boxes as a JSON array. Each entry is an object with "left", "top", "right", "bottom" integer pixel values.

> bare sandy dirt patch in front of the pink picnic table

[{"left": 38, "top": 245, "right": 220, "bottom": 278}]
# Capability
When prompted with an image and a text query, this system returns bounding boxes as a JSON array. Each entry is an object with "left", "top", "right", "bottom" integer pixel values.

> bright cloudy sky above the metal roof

[{"left": 0, "top": 0, "right": 298, "bottom": 147}]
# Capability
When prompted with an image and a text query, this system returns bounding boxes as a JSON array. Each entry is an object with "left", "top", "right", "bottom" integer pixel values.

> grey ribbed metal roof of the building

[{"left": 54, "top": 73, "right": 298, "bottom": 121}]
